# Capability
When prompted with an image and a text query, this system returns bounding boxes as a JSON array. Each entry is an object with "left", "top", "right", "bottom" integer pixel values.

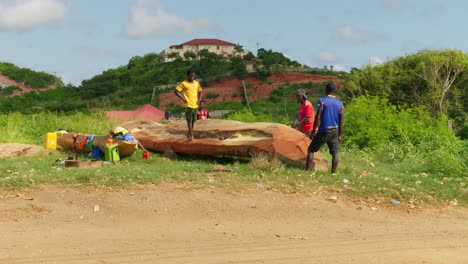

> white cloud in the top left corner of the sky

[{"left": 0, "top": 0, "right": 69, "bottom": 31}]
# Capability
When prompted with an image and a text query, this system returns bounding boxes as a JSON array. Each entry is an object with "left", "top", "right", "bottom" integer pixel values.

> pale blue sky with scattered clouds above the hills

[{"left": 0, "top": 0, "right": 468, "bottom": 85}]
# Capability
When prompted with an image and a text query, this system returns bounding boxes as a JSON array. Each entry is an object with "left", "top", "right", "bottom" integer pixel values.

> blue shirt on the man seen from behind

[{"left": 317, "top": 95, "right": 344, "bottom": 132}]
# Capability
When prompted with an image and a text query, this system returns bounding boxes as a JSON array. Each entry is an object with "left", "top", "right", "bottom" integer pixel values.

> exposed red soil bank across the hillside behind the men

[{"left": 159, "top": 73, "right": 343, "bottom": 110}]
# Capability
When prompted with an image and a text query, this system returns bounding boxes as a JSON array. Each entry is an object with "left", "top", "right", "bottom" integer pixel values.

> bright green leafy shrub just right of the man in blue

[{"left": 343, "top": 96, "right": 468, "bottom": 175}]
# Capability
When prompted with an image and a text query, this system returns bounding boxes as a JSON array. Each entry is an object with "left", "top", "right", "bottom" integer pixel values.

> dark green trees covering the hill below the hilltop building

[{"left": 0, "top": 45, "right": 302, "bottom": 113}]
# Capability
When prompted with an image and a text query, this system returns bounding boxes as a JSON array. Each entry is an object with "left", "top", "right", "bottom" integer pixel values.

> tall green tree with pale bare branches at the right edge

[{"left": 345, "top": 49, "right": 468, "bottom": 124}]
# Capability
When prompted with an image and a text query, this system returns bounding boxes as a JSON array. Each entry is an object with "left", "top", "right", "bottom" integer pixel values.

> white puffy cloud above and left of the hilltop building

[{"left": 125, "top": 0, "right": 215, "bottom": 38}]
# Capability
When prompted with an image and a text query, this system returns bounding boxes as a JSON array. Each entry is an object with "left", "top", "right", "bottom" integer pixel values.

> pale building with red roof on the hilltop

[{"left": 159, "top": 39, "right": 248, "bottom": 62}]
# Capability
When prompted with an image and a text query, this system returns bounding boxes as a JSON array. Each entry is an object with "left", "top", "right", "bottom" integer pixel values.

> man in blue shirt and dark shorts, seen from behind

[{"left": 306, "top": 83, "right": 344, "bottom": 175}]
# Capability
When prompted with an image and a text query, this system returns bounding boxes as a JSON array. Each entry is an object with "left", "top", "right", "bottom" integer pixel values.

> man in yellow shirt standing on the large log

[{"left": 174, "top": 70, "right": 202, "bottom": 141}]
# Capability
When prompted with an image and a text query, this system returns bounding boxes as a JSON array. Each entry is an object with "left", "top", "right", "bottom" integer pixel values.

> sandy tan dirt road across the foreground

[{"left": 0, "top": 185, "right": 468, "bottom": 264}]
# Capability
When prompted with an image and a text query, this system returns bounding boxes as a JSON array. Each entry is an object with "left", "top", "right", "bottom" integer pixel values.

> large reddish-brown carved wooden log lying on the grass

[{"left": 119, "top": 119, "right": 328, "bottom": 170}]
